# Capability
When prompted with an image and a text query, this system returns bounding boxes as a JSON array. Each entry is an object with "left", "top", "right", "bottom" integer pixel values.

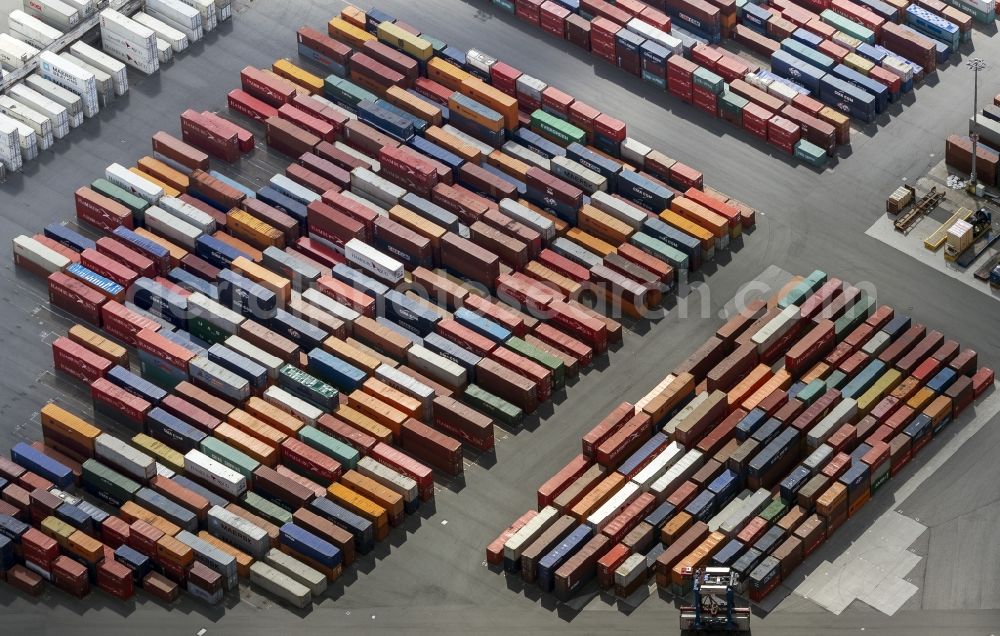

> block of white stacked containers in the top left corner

[{"left": 0, "top": 0, "right": 232, "bottom": 172}]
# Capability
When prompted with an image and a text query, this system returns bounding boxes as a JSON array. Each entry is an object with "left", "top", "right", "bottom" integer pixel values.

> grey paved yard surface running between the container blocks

[{"left": 0, "top": 0, "right": 1000, "bottom": 636}]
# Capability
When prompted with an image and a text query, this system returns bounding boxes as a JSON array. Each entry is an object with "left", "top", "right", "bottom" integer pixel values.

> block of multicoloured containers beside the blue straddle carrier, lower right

[{"left": 486, "top": 271, "right": 994, "bottom": 601}]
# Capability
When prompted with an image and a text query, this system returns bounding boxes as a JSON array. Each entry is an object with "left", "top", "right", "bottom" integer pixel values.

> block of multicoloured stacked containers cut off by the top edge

[{"left": 494, "top": 0, "right": 995, "bottom": 166}]
